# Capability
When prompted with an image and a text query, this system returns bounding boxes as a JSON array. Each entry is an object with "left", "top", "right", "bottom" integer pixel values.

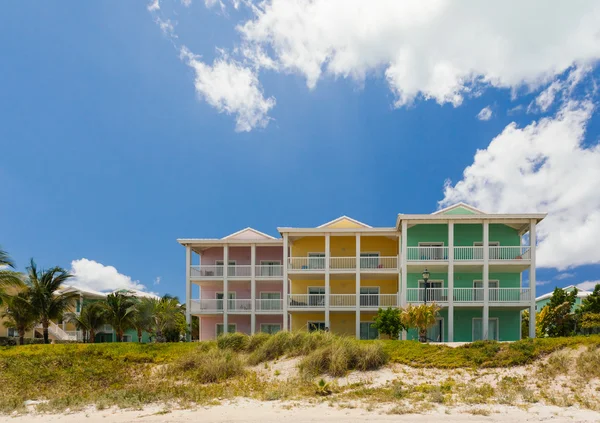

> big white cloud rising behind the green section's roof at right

[{"left": 440, "top": 100, "right": 600, "bottom": 270}]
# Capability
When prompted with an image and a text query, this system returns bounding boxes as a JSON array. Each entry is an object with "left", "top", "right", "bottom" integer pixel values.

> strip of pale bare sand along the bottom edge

[{"left": 0, "top": 400, "right": 600, "bottom": 423}]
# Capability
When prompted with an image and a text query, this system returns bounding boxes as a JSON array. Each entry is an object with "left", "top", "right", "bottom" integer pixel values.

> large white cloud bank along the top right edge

[{"left": 238, "top": 0, "right": 600, "bottom": 107}]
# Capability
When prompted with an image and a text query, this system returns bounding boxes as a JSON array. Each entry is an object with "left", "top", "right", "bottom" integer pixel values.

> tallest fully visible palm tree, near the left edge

[{"left": 25, "top": 259, "right": 79, "bottom": 344}]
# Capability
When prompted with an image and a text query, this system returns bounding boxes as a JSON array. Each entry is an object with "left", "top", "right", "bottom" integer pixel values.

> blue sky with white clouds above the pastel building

[{"left": 0, "top": 0, "right": 600, "bottom": 298}]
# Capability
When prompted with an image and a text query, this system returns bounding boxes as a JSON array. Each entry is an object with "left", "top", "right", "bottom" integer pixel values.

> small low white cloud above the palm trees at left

[{"left": 69, "top": 258, "right": 146, "bottom": 291}]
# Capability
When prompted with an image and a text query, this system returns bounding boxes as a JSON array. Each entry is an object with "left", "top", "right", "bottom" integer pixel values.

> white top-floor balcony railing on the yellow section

[{"left": 288, "top": 256, "right": 398, "bottom": 273}]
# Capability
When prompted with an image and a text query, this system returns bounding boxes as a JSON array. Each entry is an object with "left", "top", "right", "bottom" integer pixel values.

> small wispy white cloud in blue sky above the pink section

[{"left": 181, "top": 47, "right": 275, "bottom": 131}]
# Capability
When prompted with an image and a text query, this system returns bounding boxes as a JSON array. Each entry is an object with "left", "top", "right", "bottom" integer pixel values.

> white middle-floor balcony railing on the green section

[{"left": 406, "top": 288, "right": 531, "bottom": 304}]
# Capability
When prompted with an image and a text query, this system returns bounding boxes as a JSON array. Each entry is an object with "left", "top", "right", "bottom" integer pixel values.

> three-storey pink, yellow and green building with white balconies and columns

[{"left": 178, "top": 203, "right": 545, "bottom": 342}]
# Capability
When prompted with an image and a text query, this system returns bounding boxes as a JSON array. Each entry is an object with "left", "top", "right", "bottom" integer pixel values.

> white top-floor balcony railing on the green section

[{"left": 406, "top": 246, "right": 531, "bottom": 262}]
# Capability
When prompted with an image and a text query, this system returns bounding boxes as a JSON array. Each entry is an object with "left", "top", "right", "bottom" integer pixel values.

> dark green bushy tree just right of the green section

[{"left": 539, "top": 288, "right": 578, "bottom": 337}]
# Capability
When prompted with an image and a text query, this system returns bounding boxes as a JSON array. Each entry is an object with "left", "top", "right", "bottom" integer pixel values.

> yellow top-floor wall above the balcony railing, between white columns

[{"left": 291, "top": 235, "right": 398, "bottom": 257}]
